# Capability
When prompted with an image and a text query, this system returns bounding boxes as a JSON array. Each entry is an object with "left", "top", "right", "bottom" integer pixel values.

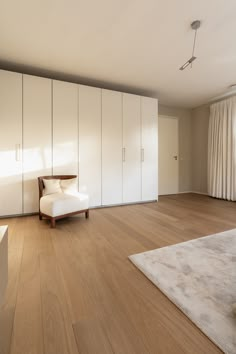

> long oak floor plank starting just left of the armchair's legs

[{"left": 11, "top": 217, "right": 44, "bottom": 354}]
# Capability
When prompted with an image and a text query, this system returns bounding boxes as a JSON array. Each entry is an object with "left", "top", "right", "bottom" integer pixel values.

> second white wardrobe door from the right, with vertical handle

[{"left": 123, "top": 93, "right": 141, "bottom": 203}]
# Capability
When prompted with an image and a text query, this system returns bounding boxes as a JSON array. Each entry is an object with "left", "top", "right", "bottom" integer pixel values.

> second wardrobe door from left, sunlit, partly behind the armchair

[{"left": 23, "top": 75, "right": 52, "bottom": 213}]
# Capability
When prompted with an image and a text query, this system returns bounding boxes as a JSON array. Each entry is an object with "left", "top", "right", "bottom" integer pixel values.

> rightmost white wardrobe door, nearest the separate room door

[{"left": 141, "top": 97, "right": 158, "bottom": 201}]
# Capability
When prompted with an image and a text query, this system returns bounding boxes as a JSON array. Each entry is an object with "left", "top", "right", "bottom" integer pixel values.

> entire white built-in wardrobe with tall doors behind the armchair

[{"left": 0, "top": 70, "right": 158, "bottom": 216}]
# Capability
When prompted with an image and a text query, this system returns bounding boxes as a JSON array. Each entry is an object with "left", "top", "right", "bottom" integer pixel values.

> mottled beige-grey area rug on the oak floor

[{"left": 129, "top": 229, "right": 236, "bottom": 354}]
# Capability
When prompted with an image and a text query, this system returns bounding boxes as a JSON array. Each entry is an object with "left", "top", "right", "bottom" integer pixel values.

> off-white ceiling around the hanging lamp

[{"left": 0, "top": 0, "right": 236, "bottom": 107}]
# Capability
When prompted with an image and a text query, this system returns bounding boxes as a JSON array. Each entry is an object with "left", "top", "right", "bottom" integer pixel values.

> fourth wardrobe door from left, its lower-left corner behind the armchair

[{"left": 79, "top": 85, "right": 102, "bottom": 206}]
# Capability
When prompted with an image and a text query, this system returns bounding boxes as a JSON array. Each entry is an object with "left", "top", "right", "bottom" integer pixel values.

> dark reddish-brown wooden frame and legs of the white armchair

[{"left": 38, "top": 175, "right": 89, "bottom": 228}]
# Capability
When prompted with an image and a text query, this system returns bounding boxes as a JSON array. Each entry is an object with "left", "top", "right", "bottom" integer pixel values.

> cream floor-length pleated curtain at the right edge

[{"left": 208, "top": 96, "right": 236, "bottom": 201}]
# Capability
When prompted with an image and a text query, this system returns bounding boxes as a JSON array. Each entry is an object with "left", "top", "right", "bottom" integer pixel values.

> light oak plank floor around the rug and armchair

[{"left": 0, "top": 194, "right": 236, "bottom": 354}]
